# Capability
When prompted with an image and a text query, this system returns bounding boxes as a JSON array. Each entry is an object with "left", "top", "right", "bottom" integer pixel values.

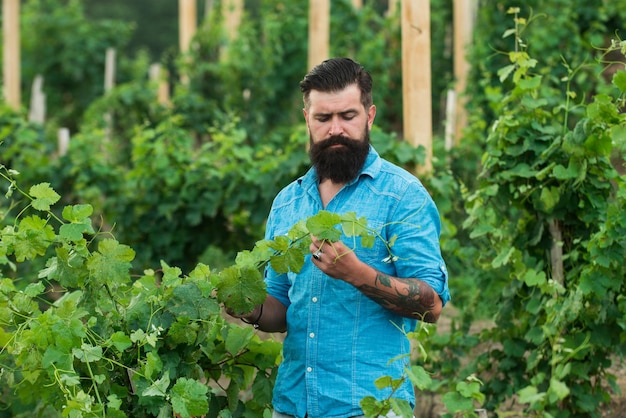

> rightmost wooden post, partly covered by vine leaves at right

[{"left": 453, "top": 0, "right": 476, "bottom": 144}]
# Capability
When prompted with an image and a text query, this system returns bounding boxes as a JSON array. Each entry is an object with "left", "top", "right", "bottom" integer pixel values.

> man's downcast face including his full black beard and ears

[{"left": 304, "top": 84, "right": 376, "bottom": 183}]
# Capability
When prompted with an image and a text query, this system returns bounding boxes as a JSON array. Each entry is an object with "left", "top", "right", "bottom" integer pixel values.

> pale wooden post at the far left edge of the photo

[{"left": 2, "top": 0, "right": 22, "bottom": 110}]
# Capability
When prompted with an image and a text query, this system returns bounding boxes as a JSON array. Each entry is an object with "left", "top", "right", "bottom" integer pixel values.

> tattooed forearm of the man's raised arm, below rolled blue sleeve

[{"left": 361, "top": 272, "right": 436, "bottom": 322}]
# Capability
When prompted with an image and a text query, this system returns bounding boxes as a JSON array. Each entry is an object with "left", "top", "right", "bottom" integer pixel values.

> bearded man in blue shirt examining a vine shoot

[{"left": 229, "top": 58, "right": 450, "bottom": 418}]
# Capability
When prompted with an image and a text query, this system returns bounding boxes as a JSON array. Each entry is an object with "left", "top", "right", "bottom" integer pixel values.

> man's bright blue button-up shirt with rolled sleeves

[{"left": 265, "top": 148, "right": 450, "bottom": 418}]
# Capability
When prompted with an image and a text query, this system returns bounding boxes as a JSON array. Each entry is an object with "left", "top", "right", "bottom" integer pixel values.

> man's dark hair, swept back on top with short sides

[{"left": 300, "top": 58, "right": 373, "bottom": 110}]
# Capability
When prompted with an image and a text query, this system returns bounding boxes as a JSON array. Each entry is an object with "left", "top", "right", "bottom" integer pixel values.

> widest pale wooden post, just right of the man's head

[{"left": 401, "top": 0, "right": 433, "bottom": 173}]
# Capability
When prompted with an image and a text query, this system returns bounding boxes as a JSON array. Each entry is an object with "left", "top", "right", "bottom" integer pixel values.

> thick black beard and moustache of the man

[{"left": 309, "top": 128, "right": 370, "bottom": 183}]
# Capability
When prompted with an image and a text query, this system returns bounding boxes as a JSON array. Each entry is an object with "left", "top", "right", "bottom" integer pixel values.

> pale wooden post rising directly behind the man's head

[{"left": 308, "top": 0, "right": 330, "bottom": 69}]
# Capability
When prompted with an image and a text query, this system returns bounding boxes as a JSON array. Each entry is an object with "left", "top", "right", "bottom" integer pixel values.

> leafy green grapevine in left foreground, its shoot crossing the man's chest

[{"left": 0, "top": 166, "right": 395, "bottom": 417}]
